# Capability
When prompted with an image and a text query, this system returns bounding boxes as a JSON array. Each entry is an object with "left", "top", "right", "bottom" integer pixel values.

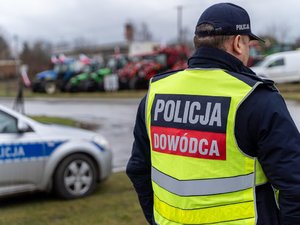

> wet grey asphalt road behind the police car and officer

[{"left": 0, "top": 99, "right": 300, "bottom": 171}]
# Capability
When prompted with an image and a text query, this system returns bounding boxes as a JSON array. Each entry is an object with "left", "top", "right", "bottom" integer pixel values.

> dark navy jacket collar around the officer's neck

[{"left": 188, "top": 47, "right": 255, "bottom": 75}]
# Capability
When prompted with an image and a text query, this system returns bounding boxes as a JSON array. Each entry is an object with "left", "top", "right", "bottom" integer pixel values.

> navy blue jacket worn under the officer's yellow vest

[{"left": 126, "top": 48, "right": 300, "bottom": 225}]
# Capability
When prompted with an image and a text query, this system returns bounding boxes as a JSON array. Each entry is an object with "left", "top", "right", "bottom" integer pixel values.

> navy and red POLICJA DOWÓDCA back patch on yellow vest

[{"left": 151, "top": 94, "right": 230, "bottom": 160}]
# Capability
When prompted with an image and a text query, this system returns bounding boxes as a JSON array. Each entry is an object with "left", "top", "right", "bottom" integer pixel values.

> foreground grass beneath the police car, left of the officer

[{"left": 0, "top": 172, "right": 147, "bottom": 225}]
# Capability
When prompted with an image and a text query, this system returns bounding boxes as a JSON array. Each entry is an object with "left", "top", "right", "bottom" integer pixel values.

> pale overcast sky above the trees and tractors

[{"left": 0, "top": 0, "right": 300, "bottom": 44}]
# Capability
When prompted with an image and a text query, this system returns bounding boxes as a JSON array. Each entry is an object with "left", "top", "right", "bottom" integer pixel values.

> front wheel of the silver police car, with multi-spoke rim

[{"left": 54, "top": 154, "right": 96, "bottom": 199}]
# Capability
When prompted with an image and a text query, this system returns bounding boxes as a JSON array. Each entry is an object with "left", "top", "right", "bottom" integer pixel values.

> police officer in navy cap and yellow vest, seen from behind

[{"left": 127, "top": 3, "right": 300, "bottom": 225}]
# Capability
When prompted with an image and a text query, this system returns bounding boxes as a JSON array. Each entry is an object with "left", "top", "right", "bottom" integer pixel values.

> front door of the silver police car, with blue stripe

[{"left": 0, "top": 110, "right": 45, "bottom": 195}]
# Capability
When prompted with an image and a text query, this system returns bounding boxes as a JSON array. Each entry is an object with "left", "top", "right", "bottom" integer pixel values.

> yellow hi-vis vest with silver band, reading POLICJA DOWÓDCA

[{"left": 146, "top": 69, "right": 267, "bottom": 225}]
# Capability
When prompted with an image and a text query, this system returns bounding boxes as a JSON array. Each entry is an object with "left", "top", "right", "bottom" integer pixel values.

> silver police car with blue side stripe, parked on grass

[{"left": 0, "top": 105, "right": 112, "bottom": 199}]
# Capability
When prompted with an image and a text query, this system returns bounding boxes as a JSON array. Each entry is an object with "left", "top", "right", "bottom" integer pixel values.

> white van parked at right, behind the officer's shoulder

[{"left": 251, "top": 51, "right": 300, "bottom": 83}]
